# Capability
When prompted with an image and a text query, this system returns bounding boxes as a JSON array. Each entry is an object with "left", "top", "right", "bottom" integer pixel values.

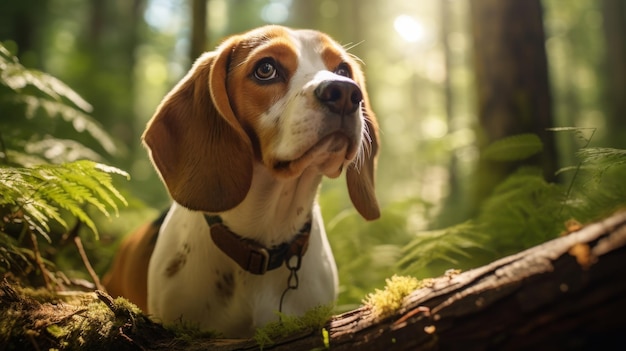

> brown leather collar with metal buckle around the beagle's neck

[{"left": 204, "top": 215, "right": 311, "bottom": 275}]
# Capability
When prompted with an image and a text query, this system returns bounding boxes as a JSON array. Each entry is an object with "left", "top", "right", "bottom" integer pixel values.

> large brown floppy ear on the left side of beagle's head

[{"left": 142, "top": 38, "right": 253, "bottom": 212}]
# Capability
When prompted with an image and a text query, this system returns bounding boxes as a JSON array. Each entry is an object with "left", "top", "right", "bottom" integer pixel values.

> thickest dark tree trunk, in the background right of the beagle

[{"left": 470, "top": 0, "right": 558, "bottom": 212}]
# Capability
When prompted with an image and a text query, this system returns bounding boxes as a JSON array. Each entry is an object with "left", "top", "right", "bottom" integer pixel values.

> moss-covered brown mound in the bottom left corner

[{"left": 0, "top": 281, "right": 173, "bottom": 351}]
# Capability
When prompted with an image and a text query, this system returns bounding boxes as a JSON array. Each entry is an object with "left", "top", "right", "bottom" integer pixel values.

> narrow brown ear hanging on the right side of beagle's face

[{"left": 346, "top": 72, "right": 380, "bottom": 220}]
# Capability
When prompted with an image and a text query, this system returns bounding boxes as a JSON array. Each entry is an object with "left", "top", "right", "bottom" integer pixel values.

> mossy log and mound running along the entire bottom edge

[{"left": 0, "top": 212, "right": 626, "bottom": 350}]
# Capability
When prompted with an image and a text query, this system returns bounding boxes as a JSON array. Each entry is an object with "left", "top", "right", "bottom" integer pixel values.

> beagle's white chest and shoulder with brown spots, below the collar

[{"left": 148, "top": 206, "right": 336, "bottom": 337}]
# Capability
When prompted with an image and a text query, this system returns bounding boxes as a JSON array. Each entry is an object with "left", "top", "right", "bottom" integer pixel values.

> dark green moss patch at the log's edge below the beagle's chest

[{"left": 254, "top": 305, "right": 333, "bottom": 349}]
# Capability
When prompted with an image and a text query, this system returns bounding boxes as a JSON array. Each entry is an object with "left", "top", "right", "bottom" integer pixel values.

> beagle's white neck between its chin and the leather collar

[{"left": 219, "top": 164, "right": 322, "bottom": 247}]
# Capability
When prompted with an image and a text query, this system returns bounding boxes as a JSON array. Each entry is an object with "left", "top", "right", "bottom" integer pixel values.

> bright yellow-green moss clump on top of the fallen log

[{"left": 363, "top": 275, "right": 425, "bottom": 319}]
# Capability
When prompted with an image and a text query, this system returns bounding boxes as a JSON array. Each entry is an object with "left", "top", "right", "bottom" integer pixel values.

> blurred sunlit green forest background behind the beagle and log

[{"left": 0, "top": 0, "right": 626, "bottom": 314}]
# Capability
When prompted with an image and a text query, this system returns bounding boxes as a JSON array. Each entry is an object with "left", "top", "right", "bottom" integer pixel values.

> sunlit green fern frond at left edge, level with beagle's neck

[{"left": 0, "top": 161, "right": 128, "bottom": 241}]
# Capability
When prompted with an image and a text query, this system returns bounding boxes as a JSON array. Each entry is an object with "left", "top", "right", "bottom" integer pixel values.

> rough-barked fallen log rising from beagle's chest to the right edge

[{"left": 227, "top": 212, "right": 626, "bottom": 350}]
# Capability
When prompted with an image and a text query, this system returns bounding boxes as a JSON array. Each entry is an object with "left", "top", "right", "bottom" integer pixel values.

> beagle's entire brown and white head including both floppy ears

[{"left": 143, "top": 26, "right": 380, "bottom": 219}]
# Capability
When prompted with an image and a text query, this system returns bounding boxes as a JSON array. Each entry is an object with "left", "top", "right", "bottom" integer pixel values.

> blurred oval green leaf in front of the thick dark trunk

[{"left": 482, "top": 133, "right": 543, "bottom": 161}]
